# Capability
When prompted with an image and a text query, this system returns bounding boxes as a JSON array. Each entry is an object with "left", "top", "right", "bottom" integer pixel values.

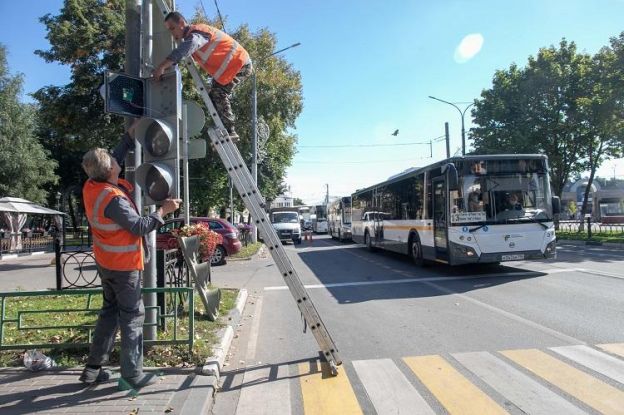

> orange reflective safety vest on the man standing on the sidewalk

[{"left": 82, "top": 179, "right": 143, "bottom": 271}]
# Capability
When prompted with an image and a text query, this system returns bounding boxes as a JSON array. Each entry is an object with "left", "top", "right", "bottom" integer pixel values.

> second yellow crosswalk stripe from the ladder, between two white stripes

[{"left": 403, "top": 355, "right": 507, "bottom": 415}]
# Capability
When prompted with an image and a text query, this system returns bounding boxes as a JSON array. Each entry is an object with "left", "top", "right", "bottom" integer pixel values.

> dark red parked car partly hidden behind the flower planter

[{"left": 156, "top": 217, "right": 242, "bottom": 265}]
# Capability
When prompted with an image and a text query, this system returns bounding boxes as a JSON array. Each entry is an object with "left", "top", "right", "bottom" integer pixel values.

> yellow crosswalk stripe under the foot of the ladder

[{"left": 299, "top": 361, "right": 362, "bottom": 415}]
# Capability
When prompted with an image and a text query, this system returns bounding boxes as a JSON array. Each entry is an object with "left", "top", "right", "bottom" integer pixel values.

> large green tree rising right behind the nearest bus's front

[{"left": 471, "top": 40, "right": 592, "bottom": 194}]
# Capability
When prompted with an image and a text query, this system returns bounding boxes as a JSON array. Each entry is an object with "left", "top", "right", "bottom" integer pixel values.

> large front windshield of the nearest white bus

[{"left": 450, "top": 160, "right": 552, "bottom": 224}]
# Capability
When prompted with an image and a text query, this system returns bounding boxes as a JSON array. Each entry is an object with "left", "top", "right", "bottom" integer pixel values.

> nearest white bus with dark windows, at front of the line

[{"left": 351, "top": 155, "right": 560, "bottom": 265}]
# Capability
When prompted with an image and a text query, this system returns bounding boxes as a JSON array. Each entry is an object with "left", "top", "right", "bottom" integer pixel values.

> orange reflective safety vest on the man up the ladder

[{"left": 190, "top": 24, "right": 251, "bottom": 85}]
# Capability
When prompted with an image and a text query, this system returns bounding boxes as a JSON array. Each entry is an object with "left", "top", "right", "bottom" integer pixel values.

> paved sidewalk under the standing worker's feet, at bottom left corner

[{"left": 0, "top": 368, "right": 216, "bottom": 415}]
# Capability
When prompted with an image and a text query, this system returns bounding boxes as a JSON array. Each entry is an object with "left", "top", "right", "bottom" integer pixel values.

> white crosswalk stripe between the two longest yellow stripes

[{"left": 451, "top": 352, "right": 586, "bottom": 415}]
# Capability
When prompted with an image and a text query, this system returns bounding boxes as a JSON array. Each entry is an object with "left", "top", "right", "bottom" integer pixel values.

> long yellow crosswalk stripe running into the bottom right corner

[{"left": 501, "top": 349, "right": 624, "bottom": 415}]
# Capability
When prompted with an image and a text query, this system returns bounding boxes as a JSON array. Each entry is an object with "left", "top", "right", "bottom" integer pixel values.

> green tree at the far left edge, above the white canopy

[{"left": 0, "top": 45, "right": 57, "bottom": 203}]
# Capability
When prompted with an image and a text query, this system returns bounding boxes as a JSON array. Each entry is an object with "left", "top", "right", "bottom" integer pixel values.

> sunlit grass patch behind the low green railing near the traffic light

[{"left": 0, "top": 289, "right": 238, "bottom": 367}]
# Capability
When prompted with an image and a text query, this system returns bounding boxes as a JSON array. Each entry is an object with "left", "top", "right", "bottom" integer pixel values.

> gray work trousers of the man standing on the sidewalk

[{"left": 87, "top": 265, "right": 145, "bottom": 379}]
